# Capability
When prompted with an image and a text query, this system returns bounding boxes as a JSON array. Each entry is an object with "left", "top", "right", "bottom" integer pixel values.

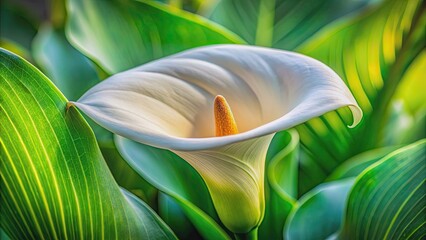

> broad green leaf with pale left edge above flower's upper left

[{"left": 63, "top": 0, "right": 242, "bottom": 73}]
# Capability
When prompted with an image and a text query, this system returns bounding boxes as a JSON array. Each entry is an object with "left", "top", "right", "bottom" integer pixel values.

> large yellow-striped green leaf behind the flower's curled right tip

[{"left": 297, "top": 0, "right": 426, "bottom": 193}]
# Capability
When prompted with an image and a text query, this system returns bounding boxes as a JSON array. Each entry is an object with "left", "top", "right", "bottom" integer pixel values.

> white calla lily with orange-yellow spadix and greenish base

[{"left": 73, "top": 45, "right": 362, "bottom": 233}]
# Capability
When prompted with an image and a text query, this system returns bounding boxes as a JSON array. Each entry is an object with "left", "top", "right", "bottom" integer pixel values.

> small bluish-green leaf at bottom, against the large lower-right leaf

[{"left": 284, "top": 178, "right": 354, "bottom": 240}]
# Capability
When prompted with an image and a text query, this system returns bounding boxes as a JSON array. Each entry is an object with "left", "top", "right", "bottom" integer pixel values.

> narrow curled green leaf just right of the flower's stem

[{"left": 259, "top": 130, "right": 299, "bottom": 239}]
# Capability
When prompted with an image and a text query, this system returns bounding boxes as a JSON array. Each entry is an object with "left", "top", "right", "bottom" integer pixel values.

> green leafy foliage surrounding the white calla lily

[{"left": 0, "top": 0, "right": 426, "bottom": 239}]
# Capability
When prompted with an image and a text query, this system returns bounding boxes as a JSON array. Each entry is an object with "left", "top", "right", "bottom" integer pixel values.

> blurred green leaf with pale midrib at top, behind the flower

[{"left": 209, "top": 0, "right": 370, "bottom": 49}]
